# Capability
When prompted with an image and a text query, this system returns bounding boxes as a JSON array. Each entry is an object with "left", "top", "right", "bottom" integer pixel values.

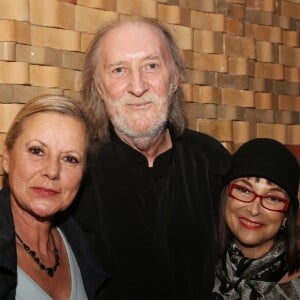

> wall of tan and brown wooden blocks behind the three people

[{"left": 0, "top": 0, "right": 300, "bottom": 186}]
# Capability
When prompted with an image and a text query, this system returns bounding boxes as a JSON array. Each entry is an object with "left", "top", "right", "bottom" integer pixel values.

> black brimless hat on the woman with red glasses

[{"left": 225, "top": 138, "right": 300, "bottom": 210}]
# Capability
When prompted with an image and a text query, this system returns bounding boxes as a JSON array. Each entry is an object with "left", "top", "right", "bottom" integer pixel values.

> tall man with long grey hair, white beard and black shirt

[{"left": 74, "top": 18, "right": 229, "bottom": 300}]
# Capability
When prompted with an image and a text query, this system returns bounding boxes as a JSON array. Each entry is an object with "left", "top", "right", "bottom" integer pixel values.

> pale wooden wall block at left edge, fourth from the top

[{"left": 0, "top": 61, "right": 29, "bottom": 84}]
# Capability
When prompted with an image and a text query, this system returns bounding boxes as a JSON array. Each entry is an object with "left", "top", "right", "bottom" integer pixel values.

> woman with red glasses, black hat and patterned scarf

[{"left": 212, "top": 138, "right": 300, "bottom": 300}]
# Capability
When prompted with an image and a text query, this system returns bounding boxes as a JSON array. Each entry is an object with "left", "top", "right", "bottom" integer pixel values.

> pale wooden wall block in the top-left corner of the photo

[{"left": 0, "top": 0, "right": 29, "bottom": 21}]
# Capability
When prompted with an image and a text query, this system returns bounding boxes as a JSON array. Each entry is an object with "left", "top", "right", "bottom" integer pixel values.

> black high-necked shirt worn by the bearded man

[{"left": 75, "top": 130, "right": 229, "bottom": 300}]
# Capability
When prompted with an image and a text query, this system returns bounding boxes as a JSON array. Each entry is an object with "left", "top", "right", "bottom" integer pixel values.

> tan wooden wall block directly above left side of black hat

[{"left": 232, "top": 121, "right": 256, "bottom": 144}]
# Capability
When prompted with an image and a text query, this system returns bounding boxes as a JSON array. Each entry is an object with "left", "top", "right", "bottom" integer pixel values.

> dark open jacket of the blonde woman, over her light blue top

[{"left": 0, "top": 189, "right": 107, "bottom": 300}]
